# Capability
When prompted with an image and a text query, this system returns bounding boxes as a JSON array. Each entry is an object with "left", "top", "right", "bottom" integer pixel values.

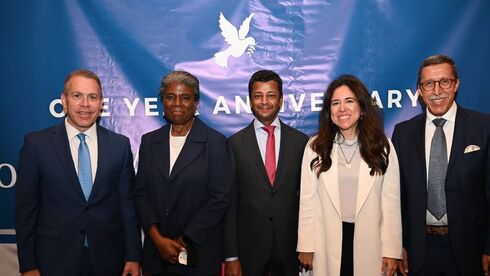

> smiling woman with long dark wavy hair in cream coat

[{"left": 297, "top": 75, "right": 402, "bottom": 276}]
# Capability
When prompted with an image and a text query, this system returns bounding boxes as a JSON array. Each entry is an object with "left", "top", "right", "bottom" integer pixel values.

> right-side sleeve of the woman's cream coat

[{"left": 381, "top": 142, "right": 402, "bottom": 259}]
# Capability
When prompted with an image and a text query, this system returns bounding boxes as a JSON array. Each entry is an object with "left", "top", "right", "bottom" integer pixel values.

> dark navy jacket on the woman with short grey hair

[{"left": 136, "top": 118, "right": 230, "bottom": 275}]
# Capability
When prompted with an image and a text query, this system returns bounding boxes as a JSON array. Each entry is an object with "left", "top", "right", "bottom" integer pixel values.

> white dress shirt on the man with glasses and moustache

[{"left": 425, "top": 103, "right": 458, "bottom": 225}]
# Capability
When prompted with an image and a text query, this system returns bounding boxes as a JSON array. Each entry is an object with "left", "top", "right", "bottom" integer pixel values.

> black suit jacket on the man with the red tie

[{"left": 225, "top": 122, "right": 308, "bottom": 266}]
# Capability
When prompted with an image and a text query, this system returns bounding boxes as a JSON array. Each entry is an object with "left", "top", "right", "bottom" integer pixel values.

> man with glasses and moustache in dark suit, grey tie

[{"left": 393, "top": 55, "right": 490, "bottom": 276}]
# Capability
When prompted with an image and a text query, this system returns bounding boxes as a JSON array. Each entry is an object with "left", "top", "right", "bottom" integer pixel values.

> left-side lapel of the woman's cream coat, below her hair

[{"left": 320, "top": 144, "right": 342, "bottom": 218}]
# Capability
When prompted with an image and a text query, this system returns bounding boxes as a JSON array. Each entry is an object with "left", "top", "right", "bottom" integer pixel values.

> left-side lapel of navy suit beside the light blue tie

[{"left": 52, "top": 121, "right": 84, "bottom": 198}]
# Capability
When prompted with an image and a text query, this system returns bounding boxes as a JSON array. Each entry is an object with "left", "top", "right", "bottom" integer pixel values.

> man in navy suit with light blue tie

[{"left": 15, "top": 70, "right": 142, "bottom": 276}]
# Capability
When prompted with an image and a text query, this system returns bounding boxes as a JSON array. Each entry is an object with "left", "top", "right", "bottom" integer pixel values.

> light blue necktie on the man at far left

[{"left": 77, "top": 133, "right": 92, "bottom": 200}]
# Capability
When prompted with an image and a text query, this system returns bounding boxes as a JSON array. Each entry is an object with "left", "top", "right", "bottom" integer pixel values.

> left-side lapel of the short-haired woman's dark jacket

[{"left": 150, "top": 124, "right": 170, "bottom": 180}]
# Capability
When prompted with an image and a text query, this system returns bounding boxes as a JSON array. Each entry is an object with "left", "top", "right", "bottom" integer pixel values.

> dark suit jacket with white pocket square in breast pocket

[{"left": 393, "top": 106, "right": 490, "bottom": 275}]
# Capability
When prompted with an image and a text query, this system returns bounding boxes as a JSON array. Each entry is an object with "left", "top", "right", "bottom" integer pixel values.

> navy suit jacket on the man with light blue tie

[{"left": 15, "top": 122, "right": 141, "bottom": 276}]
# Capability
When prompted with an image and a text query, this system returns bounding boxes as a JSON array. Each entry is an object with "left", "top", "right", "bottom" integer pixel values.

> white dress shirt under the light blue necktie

[{"left": 65, "top": 119, "right": 98, "bottom": 183}]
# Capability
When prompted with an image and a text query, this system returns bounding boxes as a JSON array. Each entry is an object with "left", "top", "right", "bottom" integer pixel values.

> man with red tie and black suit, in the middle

[{"left": 225, "top": 70, "right": 308, "bottom": 276}]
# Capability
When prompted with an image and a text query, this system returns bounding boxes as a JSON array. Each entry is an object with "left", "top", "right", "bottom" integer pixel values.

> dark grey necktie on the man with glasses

[{"left": 427, "top": 118, "right": 447, "bottom": 220}]
